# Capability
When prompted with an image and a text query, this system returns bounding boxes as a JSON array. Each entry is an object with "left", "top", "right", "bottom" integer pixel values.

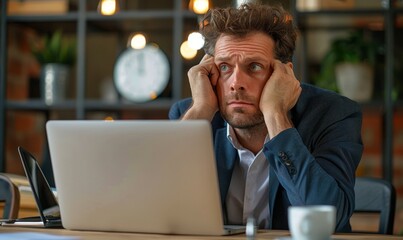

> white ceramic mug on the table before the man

[{"left": 288, "top": 205, "right": 336, "bottom": 240}]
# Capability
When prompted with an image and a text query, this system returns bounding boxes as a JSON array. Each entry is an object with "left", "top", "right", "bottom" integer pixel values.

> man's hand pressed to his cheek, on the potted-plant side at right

[{"left": 259, "top": 60, "right": 302, "bottom": 115}]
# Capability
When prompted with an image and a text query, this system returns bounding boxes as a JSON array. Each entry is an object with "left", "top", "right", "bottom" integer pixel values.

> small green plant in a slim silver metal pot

[{"left": 33, "top": 31, "right": 76, "bottom": 105}]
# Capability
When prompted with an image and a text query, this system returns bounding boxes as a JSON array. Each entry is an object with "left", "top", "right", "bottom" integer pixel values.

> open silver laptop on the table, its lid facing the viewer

[{"left": 46, "top": 120, "right": 244, "bottom": 235}]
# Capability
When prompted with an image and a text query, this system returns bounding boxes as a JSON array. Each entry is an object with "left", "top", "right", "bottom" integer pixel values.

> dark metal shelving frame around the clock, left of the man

[{"left": 0, "top": 0, "right": 197, "bottom": 172}]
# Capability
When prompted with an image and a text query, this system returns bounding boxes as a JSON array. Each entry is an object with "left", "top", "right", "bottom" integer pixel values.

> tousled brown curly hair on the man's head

[{"left": 200, "top": 3, "right": 297, "bottom": 63}]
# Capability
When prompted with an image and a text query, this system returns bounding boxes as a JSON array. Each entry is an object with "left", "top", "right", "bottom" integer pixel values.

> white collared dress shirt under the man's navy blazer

[{"left": 226, "top": 125, "right": 270, "bottom": 228}]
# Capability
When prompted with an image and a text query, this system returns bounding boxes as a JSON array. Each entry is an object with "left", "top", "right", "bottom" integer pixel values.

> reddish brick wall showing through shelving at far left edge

[{"left": 6, "top": 27, "right": 45, "bottom": 174}]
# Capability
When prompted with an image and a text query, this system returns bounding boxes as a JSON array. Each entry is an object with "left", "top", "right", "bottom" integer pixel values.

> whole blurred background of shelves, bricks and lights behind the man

[{"left": 0, "top": 0, "right": 403, "bottom": 234}]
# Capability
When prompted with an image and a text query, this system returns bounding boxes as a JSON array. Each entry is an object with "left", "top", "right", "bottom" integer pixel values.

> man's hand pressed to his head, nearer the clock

[{"left": 188, "top": 55, "right": 219, "bottom": 117}]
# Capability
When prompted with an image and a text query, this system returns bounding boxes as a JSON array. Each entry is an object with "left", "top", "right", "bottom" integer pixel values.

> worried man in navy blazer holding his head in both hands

[{"left": 170, "top": 3, "right": 363, "bottom": 232}]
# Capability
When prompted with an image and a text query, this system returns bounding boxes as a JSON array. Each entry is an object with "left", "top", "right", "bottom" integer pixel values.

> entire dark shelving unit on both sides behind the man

[{"left": 0, "top": 0, "right": 403, "bottom": 184}]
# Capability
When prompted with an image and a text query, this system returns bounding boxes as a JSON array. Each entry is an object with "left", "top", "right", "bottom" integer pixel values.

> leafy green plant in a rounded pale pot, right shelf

[{"left": 315, "top": 30, "right": 379, "bottom": 102}]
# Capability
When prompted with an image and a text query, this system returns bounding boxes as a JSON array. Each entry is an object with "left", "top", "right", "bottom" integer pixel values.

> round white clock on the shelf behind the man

[{"left": 113, "top": 45, "right": 170, "bottom": 102}]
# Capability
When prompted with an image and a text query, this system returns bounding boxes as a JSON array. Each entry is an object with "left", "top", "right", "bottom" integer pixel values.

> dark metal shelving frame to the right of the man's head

[{"left": 292, "top": 0, "right": 403, "bottom": 182}]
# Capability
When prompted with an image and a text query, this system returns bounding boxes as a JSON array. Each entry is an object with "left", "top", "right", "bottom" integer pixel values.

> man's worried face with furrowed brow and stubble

[{"left": 214, "top": 33, "right": 275, "bottom": 128}]
